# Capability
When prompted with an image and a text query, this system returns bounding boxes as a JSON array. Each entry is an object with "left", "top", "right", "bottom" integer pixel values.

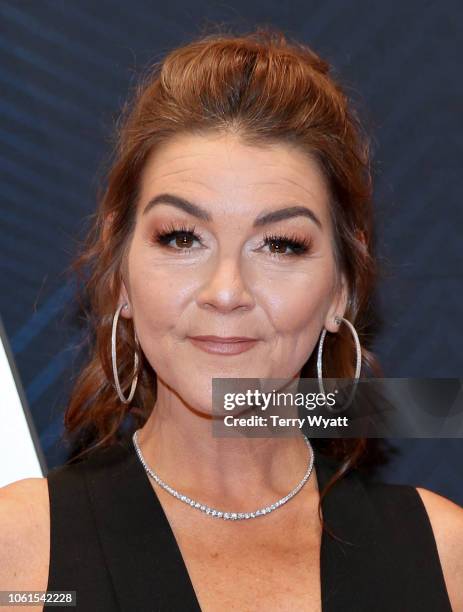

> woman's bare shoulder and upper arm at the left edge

[{"left": 0, "top": 478, "right": 50, "bottom": 590}]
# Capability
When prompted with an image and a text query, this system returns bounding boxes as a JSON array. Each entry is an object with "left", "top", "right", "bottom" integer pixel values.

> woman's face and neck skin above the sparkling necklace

[{"left": 120, "top": 134, "right": 347, "bottom": 511}]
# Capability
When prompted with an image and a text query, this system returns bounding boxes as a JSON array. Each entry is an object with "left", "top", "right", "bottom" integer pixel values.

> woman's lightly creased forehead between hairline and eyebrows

[{"left": 139, "top": 133, "right": 329, "bottom": 220}]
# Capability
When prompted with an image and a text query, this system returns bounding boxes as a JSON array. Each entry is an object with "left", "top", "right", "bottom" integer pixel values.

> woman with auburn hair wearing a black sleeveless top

[{"left": 0, "top": 30, "right": 463, "bottom": 612}]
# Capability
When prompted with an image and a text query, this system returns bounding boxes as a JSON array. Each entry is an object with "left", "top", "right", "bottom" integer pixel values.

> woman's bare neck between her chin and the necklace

[{"left": 132, "top": 383, "right": 317, "bottom": 512}]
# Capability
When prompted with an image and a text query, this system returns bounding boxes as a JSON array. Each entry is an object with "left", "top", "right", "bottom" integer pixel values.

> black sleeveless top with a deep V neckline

[{"left": 47, "top": 441, "right": 452, "bottom": 612}]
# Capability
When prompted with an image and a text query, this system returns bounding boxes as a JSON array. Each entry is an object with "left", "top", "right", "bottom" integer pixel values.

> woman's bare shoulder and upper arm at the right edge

[{"left": 416, "top": 487, "right": 463, "bottom": 612}]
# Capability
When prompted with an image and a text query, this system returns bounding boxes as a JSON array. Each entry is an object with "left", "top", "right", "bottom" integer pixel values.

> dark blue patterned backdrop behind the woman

[{"left": 0, "top": 0, "right": 463, "bottom": 504}]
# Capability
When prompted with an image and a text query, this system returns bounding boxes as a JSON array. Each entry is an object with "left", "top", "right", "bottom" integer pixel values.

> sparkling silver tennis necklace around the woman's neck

[{"left": 132, "top": 430, "right": 314, "bottom": 521}]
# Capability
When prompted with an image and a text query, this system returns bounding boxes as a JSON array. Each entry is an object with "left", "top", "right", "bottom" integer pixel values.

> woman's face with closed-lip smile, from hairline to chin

[{"left": 121, "top": 134, "right": 347, "bottom": 411}]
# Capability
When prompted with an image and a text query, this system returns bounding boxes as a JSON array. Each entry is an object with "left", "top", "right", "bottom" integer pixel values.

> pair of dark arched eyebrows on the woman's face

[{"left": 142, "top": 193, "right": 323, "bottom": 229}]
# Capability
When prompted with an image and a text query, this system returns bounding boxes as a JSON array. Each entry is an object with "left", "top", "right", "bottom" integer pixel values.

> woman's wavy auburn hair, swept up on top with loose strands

[{"left": 64, "top": 27, "right": 388, "bottom": 544}]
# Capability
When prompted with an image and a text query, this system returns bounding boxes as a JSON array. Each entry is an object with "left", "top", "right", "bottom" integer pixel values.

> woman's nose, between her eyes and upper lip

[{"left": 197, "top": 258, "right": 255, "bottom": 313}]
